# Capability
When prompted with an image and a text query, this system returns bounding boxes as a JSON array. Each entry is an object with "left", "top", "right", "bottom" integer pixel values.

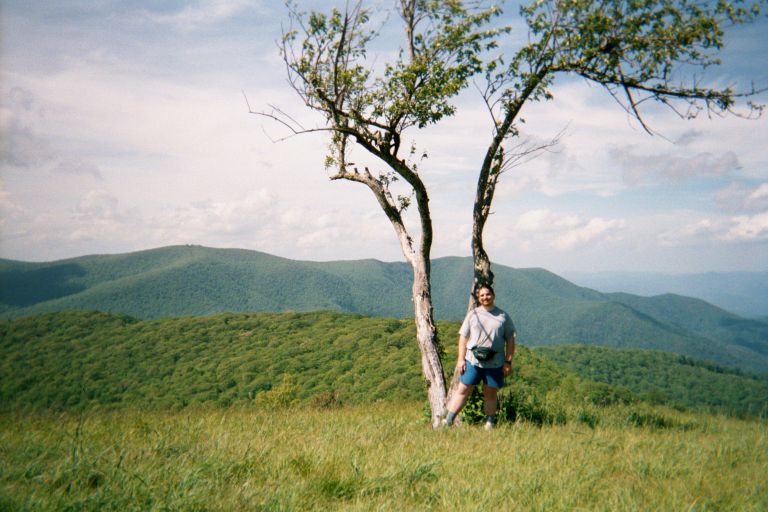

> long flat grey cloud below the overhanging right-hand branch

[{"left": 608, "top": 145, "right": 741, "bottom": 185}]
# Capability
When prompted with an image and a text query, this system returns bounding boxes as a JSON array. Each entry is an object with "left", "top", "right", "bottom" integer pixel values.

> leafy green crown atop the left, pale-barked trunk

[{"left": 282, "top": 0, "right": 500, "bottom": 152}]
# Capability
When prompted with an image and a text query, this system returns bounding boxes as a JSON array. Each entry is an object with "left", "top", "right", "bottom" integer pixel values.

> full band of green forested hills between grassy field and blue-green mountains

[{"left": 0, "top": 312, "right": 768, "bottom": 415}]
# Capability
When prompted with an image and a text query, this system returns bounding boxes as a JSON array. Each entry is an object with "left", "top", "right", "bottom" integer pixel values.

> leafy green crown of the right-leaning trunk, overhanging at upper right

[{"left": 508, "top": 0, "right": 760, "bottom": 123}]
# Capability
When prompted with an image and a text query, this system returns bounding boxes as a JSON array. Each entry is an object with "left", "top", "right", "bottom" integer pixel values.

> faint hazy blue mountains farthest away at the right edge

[{"left": 562, "top": 272, "right": 768, "bottom": 319}]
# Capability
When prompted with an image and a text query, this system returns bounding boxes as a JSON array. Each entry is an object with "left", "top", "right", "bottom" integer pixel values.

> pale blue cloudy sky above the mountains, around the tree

[{"left": 0, "top": 0, "right": 768, "bottom": 273}]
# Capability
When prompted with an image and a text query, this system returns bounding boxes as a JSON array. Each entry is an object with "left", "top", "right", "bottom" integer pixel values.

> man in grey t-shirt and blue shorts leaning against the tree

[{"left": 443, "top": 285, "right": 515, "bottom": 430}]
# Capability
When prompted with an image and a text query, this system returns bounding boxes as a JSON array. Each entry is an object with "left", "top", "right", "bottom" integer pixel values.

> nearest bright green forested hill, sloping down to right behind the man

[{"left": 0, "top": 312, "right": 615, "bottom": 411}]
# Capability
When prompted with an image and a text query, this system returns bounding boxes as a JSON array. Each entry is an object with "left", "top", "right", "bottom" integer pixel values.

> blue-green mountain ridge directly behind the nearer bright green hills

[{"left": 0, "top": 246, "right": 768, "bottom": 373}]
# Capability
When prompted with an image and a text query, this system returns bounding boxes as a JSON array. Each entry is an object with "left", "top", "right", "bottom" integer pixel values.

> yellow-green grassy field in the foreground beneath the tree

[{"left": 0, "top": 403, "right": 768, "bottom": 511}]
